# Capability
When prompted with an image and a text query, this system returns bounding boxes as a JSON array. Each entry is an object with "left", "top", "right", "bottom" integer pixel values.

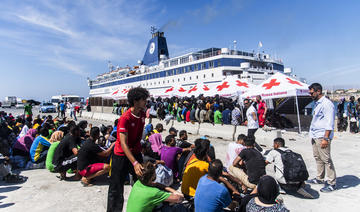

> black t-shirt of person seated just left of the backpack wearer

[{"left": 239, "top": 148, "right": 266, "bottom": 184}]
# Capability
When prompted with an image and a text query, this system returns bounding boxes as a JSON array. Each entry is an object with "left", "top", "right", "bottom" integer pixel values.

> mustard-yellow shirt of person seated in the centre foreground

[{"left": 181, "top": 158, "right": 209, "bottom": 197}]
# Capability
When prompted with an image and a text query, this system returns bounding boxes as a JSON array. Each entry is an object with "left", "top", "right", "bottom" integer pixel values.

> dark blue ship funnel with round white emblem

[{"left": 142, "top": 27, "right": 169, "bottom": 66}]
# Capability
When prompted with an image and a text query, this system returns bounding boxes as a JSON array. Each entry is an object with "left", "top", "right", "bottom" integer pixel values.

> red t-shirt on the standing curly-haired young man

[{"left": 114, "top": 109, "right": 145, "bottom": 156}]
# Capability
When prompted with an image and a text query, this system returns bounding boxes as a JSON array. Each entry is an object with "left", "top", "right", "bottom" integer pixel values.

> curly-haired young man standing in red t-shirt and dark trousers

[{"left": 107, "top": 87, "right": 150, "bottom": 212}]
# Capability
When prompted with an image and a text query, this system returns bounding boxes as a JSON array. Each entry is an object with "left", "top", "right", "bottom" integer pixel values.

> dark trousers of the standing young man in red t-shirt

[{"left": 107, "top": 154, "right": 143, "bottom": 212}]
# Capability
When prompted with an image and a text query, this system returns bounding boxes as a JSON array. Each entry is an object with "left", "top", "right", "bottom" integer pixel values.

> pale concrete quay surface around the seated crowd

[{"left": 0, "top": 109, "right": 360, "bottom": 212}]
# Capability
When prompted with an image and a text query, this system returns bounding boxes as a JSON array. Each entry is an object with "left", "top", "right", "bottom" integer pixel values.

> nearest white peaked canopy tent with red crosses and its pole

[{"left": 241, "top": 72, "right": 309, "bottom": 133}]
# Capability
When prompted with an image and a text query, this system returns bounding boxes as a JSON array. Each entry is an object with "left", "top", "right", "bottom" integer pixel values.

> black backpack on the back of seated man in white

[{"left": 276, "top": 149, "right": 309, "bottom": 183}]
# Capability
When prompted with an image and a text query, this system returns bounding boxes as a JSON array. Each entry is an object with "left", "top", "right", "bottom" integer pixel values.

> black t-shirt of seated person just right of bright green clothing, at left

[{"left": 53, "top": 134, "right": 80, "bottom": 166}]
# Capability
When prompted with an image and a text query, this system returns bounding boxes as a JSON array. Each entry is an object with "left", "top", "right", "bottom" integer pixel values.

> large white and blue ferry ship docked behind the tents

[{"left": 88, "top": 28, "right": 286, "bottom": 97}]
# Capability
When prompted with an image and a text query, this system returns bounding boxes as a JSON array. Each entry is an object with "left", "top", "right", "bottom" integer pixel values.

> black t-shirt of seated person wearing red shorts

[{"left": 77, "top": 139, "right": 104, "bottom": 170}]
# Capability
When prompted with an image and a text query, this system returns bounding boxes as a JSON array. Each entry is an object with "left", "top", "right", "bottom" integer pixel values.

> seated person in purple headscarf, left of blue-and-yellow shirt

[{"left": 13, "top": 129, "right": 37, "bottom": 157}]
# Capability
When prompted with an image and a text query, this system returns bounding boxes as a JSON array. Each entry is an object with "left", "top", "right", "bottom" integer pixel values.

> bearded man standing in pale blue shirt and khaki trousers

[{"left": 307, "top": 83, "right": 336, "bottom": 192}]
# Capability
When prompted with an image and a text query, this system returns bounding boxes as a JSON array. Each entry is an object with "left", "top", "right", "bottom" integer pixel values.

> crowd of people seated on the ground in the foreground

[{"left": 0, "top": 106, "right": 313, "bottom": 212}]
